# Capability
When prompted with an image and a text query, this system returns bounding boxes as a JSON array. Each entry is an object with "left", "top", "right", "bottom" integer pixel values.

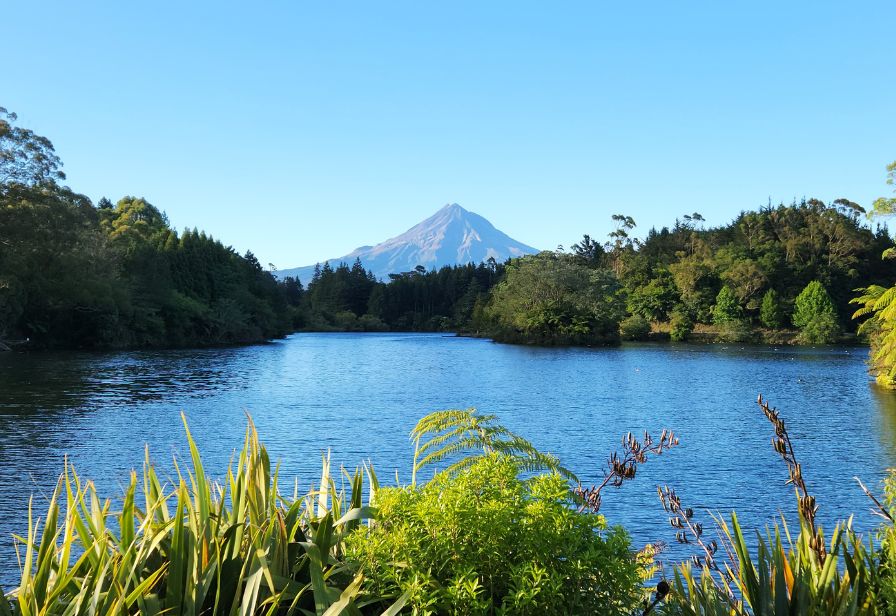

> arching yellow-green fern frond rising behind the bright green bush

[{"left": 411, "top": 408, "right": 578, "bottom": 484}]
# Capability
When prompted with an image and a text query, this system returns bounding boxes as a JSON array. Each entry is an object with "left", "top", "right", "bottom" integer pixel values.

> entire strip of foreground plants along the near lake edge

[{"left": 0, "top": 398, "right": 896, "bottom": 616}]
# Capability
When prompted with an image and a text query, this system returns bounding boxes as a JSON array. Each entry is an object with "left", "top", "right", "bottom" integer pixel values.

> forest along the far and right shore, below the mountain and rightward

[{"left": 300, "top": 199, "right": 896, "bottom": 344}]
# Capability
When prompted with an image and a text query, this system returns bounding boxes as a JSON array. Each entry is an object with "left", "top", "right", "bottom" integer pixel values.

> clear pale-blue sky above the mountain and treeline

[{"left": 0, "top": 0, "right": 896, "bottom": 268}]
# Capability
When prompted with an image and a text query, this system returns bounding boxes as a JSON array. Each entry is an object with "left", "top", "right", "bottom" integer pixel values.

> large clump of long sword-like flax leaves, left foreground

[{"left": 0, "top": 420, "right": 403, "bottom": 616}]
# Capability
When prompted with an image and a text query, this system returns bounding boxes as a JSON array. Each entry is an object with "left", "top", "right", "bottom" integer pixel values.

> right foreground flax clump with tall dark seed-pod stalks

[{"left": 661, "top": 396, "right": 879, "bottom": 616}]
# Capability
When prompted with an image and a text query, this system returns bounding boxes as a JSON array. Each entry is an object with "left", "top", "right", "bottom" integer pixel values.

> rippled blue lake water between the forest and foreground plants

[{"left": 0, "top": 334, "right": 896, "bottom": 585}]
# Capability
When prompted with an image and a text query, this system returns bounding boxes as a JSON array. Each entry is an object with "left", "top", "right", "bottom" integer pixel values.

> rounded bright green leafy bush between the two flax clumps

[{"left": 346, "top": 453, "right": 642, "bottom": 615}]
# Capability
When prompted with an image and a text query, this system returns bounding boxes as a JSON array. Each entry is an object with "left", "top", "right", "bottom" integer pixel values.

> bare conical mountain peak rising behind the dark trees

[{"left": 277, "top": 203, "right": 538, "bottom": 285}]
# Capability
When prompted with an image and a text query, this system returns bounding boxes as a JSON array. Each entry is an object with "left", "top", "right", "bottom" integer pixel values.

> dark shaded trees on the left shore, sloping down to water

[{"left": 0, "top": 110, "right": 294, "bottom": 347}]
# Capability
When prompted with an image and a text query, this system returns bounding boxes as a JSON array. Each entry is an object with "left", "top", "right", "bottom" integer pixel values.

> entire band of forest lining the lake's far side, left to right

[{"left": 0, "top": 103, "right": 896, "bottom": 356}]
